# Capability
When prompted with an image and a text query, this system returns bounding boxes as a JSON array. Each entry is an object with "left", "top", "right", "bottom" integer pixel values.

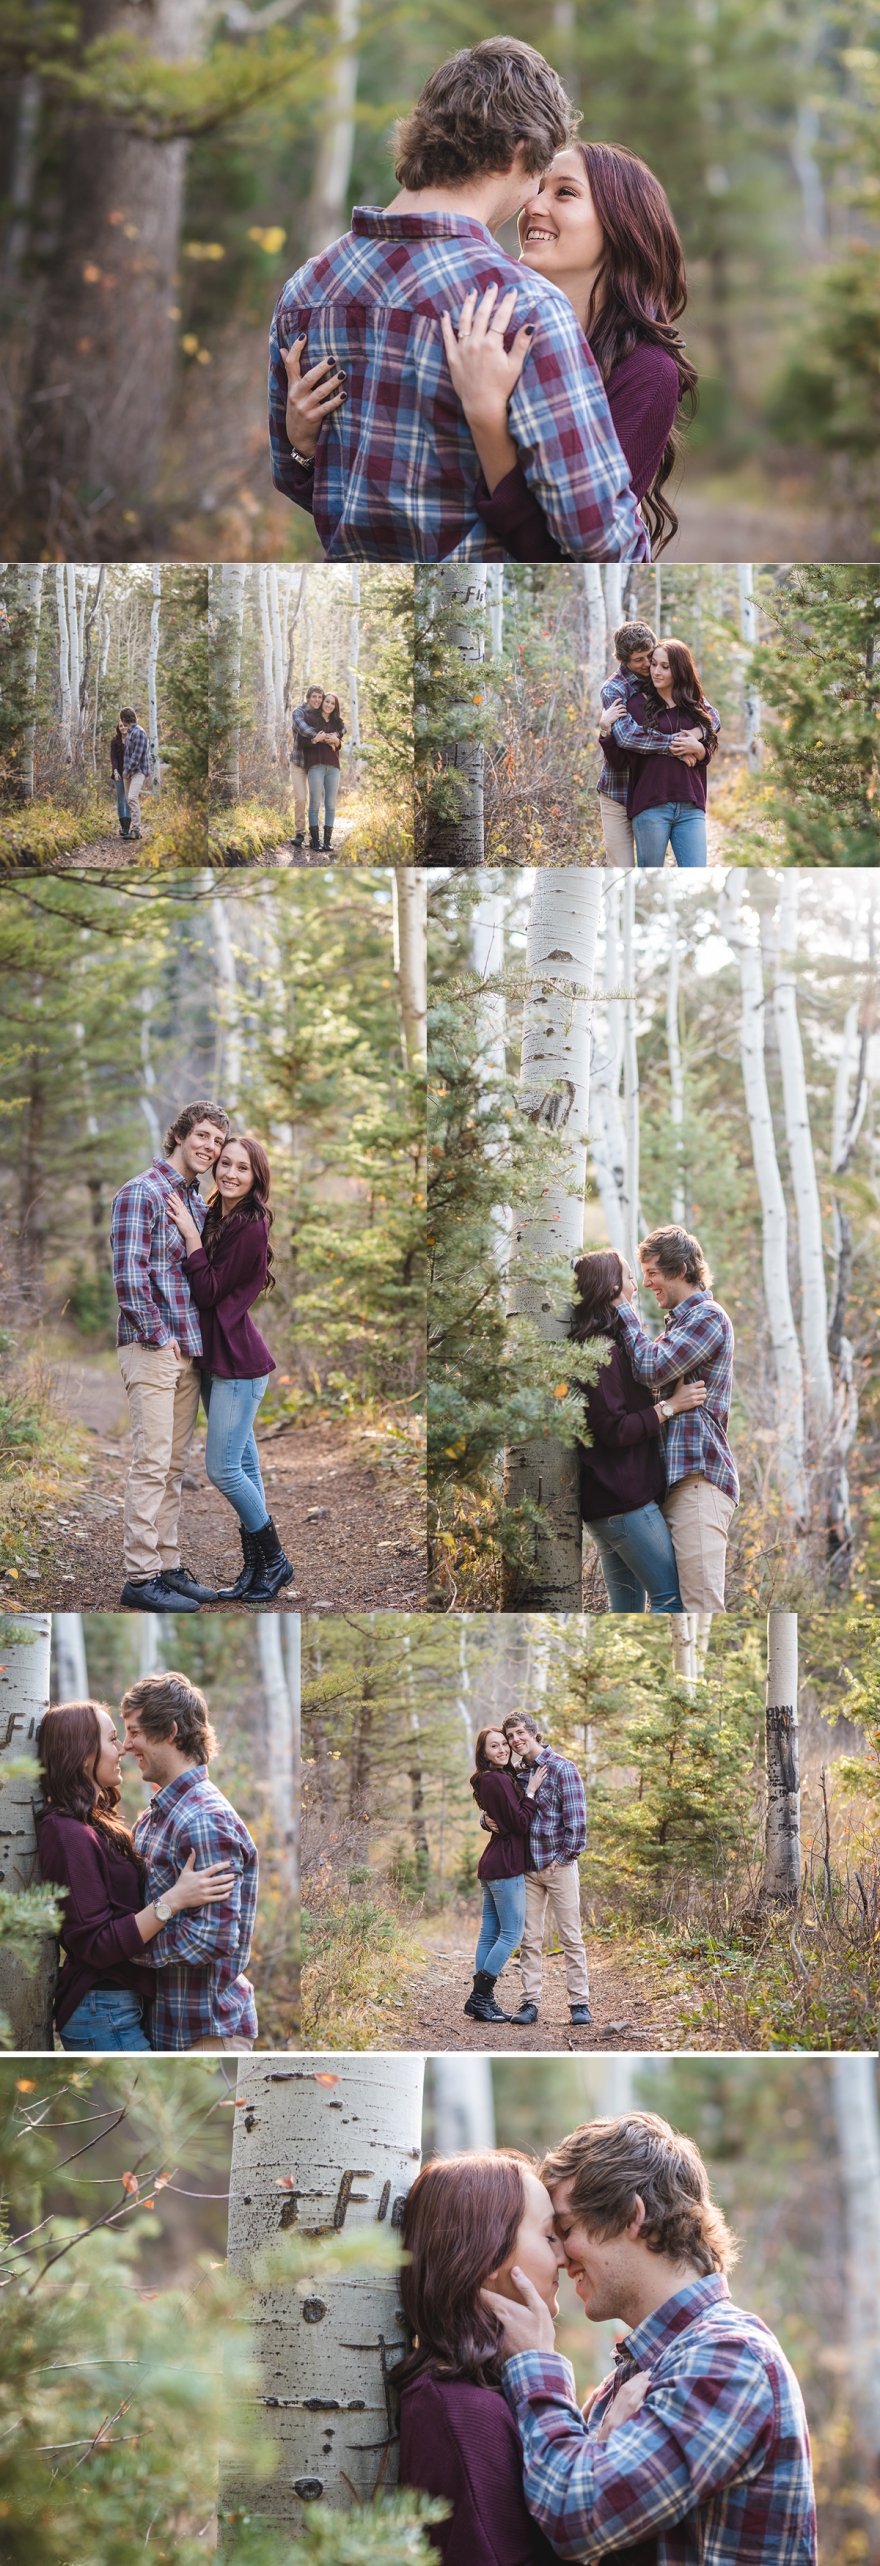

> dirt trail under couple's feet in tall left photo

[{"left": 3, "top": 1355, "right": 426, "bottom": 1611}]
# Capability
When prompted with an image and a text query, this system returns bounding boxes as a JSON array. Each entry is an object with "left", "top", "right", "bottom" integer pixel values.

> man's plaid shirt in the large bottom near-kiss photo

[{"left": 500, "top": 2273, "right": 816, "bottom": 2566}]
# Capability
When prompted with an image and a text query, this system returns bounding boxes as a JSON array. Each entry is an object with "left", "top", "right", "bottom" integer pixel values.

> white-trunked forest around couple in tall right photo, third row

[{"left": 428, "top": 872, "right": 880, "bottom": 1611}]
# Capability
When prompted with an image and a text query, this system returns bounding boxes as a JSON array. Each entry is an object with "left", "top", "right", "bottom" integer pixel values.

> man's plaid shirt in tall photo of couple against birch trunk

[{"left": 618, "top": 1291, "right": 739, "bottom": 1506}]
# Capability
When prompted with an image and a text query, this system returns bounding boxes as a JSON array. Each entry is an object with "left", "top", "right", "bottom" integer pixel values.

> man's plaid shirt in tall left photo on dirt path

[{"left": 110, "top": 1157, "right": 208, "bottom": 1357}]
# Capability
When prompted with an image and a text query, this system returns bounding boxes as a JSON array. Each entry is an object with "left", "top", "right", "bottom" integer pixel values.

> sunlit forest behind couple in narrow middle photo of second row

[{"left": 208, "top": 562, "right": 413, "bottom": 865}]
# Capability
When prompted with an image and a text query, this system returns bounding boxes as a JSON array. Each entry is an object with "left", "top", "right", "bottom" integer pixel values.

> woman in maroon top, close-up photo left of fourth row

[{"left": 38, "top": 1701, "right": 233, "bottom": 2050}]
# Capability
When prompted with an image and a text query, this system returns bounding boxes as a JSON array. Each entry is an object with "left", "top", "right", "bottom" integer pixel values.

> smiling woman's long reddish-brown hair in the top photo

[{"left": 577, "top": 141, "right": 698, "bottom": 559}]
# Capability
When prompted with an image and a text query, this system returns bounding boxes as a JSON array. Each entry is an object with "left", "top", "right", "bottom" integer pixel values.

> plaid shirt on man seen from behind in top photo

[{"left": 269, "top": 205, "right": 649, "bottom": 562}]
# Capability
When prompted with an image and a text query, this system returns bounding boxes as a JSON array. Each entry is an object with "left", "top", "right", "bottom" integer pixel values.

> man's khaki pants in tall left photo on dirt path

[{"left": 118, "top": 1345, "right": 203, "bottom": 1578}]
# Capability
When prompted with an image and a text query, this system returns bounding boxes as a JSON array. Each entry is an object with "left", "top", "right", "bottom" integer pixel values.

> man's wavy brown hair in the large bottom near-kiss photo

[{"left": 539, "top": 2112, "right": 739, "bottom": 2273}]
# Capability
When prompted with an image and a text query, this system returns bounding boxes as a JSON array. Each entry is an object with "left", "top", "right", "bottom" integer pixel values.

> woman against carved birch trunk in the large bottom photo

[{"left": 393, "top": 2150, "right": 564, "bottom": 2566}]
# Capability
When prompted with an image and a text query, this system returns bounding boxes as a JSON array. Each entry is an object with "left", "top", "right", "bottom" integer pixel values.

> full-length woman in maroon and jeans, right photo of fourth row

[{"left": 464, "top": 1729, "right": 544, "bottom": 2022}]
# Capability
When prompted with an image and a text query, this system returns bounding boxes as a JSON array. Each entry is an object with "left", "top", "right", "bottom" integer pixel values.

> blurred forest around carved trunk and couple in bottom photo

[{"left": 0, "top": 2058, "right": 880, "bottom": 2566}]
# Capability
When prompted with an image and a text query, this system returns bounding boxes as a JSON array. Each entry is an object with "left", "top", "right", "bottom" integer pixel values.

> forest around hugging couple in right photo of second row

[{"left": 416, "top": 562, "right": 880, "bottom": 870}]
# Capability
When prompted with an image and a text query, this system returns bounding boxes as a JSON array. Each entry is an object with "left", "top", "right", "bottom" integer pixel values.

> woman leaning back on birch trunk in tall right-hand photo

[{"left": 572, "top": 1250, "right": 706, "bottom": 1611}]
